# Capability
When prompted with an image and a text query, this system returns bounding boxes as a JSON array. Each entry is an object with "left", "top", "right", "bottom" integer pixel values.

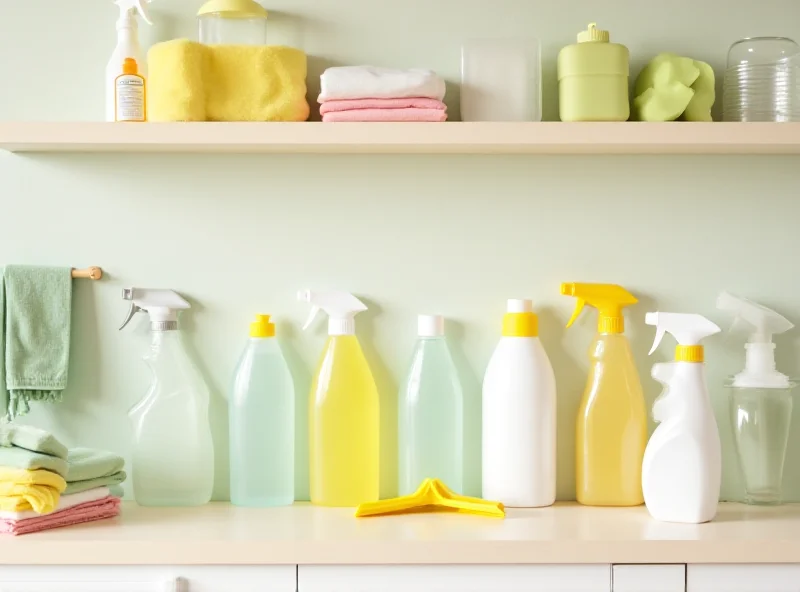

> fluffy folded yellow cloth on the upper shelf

[{"left": 147, "top": 39, "right": 310, "bottom": 121}]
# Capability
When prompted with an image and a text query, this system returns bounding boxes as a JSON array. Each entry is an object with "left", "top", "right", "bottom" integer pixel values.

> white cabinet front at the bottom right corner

[{"left": 686, "top": 564, "right": 800, "bottom": 592}]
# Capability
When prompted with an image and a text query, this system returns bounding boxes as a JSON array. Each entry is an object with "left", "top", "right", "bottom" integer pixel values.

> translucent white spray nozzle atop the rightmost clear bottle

[{"left": 717, "top": 292, "right": 794, "bottom": 388}]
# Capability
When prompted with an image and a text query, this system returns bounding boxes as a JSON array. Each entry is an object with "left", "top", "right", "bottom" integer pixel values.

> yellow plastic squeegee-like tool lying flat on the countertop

[{"left": 356, "top": 479, "right": 506, "bottom": 518}]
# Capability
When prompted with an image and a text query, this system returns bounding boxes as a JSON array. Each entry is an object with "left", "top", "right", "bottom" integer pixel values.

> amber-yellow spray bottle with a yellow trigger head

[{"left": 561, "top": 283, "right": 647, "bottom": 506}]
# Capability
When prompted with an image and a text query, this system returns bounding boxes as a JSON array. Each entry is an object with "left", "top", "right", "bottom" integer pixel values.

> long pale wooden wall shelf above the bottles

[{"left": 0, "top": 122, "right": 800, "bottom": 154}]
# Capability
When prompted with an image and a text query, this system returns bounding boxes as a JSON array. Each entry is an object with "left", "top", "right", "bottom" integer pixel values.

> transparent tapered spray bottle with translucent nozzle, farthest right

[{"left": 717, "top": 292, "right": 796, "bottom": 505}]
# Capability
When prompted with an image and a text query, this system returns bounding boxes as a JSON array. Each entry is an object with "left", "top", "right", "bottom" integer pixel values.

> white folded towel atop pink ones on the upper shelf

[{"left": 319, "top": 66, "right": 445, "bottom": 103}]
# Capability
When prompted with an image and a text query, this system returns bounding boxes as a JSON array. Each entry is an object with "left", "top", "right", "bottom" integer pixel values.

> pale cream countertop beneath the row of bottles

[{"left": 0, "top": 502, "right": 800, "bottom": 565}]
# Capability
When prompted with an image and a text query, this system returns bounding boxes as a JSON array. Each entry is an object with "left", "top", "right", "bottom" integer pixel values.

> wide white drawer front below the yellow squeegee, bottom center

[{"left": 298, "top": 565, "right": 611, "bottom": 592}]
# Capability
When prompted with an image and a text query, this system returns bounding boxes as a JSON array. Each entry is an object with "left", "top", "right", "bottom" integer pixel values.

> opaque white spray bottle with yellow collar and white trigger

[{"left": 642, "top": 312, "right": 722, "bottom": 524}]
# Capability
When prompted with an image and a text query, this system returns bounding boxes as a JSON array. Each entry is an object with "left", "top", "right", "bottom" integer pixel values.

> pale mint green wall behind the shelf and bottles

[{"left": 0, "top": 0, "right": 800, "bottom": 500}]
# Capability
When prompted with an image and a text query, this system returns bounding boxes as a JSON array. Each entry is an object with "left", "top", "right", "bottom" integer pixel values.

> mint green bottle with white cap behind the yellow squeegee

[{"left": 398, "top": 315, "right": 464, "bottom": 495}]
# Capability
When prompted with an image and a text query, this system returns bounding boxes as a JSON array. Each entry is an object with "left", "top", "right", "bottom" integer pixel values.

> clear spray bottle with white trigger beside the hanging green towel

[{"left": 120, "top": 288, "right": 214, "bottom": 506}]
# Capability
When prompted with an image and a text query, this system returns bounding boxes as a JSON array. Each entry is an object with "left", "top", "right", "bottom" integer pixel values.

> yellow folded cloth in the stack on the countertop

[{"left": 0, "top": 467, "right": 67, "bottom": 514}]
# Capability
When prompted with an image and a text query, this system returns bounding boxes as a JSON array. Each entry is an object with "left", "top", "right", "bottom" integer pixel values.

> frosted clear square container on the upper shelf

[{"left": 461, "top": 39, "right": 542, "bottom": 121}]
